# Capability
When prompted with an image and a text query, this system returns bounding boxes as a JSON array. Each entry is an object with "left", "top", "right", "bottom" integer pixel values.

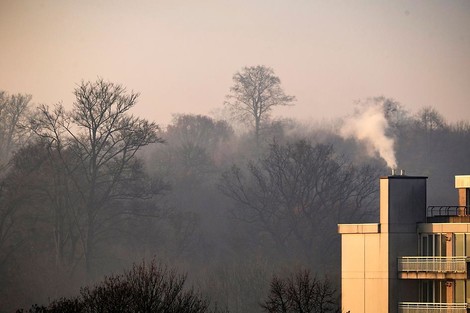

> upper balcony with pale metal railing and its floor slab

[{"left": 398, "top": 256, "right": 467, "bottom": 279}]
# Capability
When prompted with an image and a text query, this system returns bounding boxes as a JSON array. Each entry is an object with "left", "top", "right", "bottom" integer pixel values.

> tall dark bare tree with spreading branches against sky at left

[{"left": 33, "top": 79, "right": 162, "bottom": 273}]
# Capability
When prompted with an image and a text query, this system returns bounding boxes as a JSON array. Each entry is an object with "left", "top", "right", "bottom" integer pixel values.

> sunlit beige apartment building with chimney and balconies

[{"left": 338, "top": 175, "right": 470, "bottom": 313}]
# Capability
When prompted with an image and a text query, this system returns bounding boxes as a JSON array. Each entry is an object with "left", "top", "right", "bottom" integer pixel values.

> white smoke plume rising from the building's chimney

[{"left": 340, "top": 103, "right": 397, "bottom": 169}]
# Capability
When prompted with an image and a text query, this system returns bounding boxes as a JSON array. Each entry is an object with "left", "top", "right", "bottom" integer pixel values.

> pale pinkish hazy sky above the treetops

[{"left": 0, "top": 0, "right": 470, "bottom": 124}]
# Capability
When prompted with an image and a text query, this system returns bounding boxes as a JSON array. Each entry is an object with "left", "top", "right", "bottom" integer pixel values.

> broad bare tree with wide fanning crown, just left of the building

[{"left": 220, "top": 141, "right": 377, "bottom": 261}]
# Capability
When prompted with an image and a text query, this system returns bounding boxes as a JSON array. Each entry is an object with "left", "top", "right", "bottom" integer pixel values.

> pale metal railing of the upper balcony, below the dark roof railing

[{"left": 398, "top": 256, "right": 467, "bottom": 273}]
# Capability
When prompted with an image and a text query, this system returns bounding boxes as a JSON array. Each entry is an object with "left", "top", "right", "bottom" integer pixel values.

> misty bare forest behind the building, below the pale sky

[{"left": 0, "top": 66, "right": 470, "bottom": 313}]
